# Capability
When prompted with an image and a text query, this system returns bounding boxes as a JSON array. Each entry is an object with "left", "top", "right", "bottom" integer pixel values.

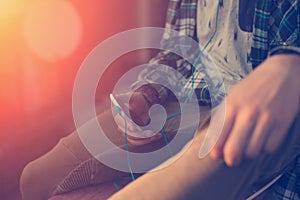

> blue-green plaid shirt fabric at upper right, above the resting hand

[{"left": 250, "top": 0, "right": 300, "bottom": 68}]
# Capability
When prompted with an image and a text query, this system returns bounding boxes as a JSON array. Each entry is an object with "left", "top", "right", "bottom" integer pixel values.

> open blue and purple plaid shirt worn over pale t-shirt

[{"left": 140, "top": 0, "right": 300, "bottom": 199}]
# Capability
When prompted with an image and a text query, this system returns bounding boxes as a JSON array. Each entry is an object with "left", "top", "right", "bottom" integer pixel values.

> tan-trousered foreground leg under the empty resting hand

[{"left": 111, "top": 111, "right": 300, "bottom": 200}]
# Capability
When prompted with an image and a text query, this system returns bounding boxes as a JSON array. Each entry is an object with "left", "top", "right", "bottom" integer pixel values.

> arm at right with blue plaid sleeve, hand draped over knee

[{"left": 211, "top": 0, "right": 300, "bottom": 165}]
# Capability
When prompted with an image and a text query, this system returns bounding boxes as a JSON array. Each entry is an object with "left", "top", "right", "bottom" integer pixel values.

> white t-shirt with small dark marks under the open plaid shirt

[{"left": 197, "top": 0, "right": 252, "bottom": 92}]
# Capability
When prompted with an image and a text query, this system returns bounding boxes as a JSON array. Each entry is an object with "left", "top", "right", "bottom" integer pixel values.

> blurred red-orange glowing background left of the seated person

[{"left": 0, "top": 0, "right": 168, "bottom": 200}]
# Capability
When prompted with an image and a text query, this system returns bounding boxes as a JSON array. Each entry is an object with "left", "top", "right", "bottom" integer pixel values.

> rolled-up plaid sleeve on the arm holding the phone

[{"left": 133, "top": 0, "right": 197, "bottom": 103}]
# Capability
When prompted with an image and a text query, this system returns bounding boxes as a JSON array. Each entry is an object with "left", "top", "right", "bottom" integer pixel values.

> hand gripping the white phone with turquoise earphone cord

[{"left": 114, "top": 92, "right": 162, "bottom": 146}]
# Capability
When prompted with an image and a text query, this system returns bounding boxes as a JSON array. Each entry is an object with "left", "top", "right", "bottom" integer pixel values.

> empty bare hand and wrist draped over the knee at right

[{"left": 211, "top": 55, "right": 300, "bottom": 166}]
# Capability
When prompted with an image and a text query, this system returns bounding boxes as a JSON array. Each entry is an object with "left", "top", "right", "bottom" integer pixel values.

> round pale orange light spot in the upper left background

[{"left": 22, "top": 0, "right": 82, "bottom": 61}]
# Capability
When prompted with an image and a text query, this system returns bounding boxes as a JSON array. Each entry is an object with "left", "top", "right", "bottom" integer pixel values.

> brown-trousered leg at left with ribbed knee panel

[{"left": 20, "top": 110, "right": 176, "bottom": 199}]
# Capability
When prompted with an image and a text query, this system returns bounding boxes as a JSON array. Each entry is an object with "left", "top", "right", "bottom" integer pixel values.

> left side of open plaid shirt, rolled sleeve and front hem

[{"left": 133, "top": 0, "right": 225, "bottom": 105}]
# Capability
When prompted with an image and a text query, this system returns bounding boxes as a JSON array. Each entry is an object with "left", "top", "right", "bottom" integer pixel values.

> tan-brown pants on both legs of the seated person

[{"left": 20, "top": 108, "right": 300, "bottom": 200}]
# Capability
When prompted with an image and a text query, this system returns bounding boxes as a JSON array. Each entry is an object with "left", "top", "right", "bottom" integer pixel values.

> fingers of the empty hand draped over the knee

[{"left": 211, "top": 102, "right": 288, "bottom": 166}]
